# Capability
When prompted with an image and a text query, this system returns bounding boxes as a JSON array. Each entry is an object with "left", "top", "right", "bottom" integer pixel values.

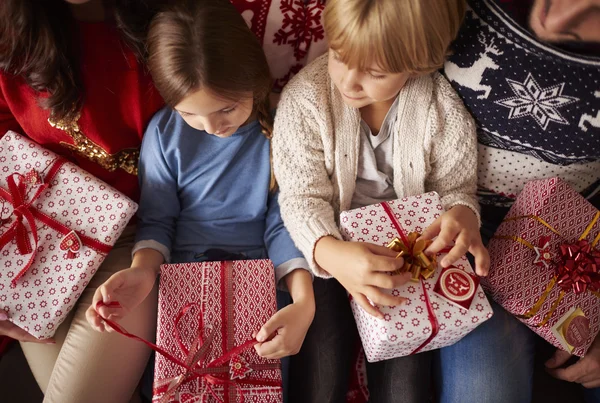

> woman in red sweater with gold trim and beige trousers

[{"left": 0, "top": 0, "right": 163, "bottom": 403}]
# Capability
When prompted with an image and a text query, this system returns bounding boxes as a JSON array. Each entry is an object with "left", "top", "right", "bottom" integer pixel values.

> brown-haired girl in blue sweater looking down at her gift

[{"left": 88, "top": 0, "right": 314, "bottom": 364}]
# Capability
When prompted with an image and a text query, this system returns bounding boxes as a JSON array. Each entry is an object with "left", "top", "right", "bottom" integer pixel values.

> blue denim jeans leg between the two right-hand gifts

[{"left": 434, "top": 300, "right": 535, "bottom": 403}]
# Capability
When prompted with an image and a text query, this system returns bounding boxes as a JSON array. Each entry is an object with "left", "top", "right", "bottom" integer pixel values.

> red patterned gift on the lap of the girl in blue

[{"left": 153, "top": 260, "right": 282, "bottom": 403}]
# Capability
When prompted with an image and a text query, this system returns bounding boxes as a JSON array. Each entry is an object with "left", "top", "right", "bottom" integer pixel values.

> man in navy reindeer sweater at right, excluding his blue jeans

[{"left": 444, "top": 0, "right": 600, "bottom": 402}]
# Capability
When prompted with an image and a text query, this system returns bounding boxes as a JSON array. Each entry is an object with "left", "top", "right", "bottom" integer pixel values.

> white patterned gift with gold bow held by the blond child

[{"left": 340, "top": 192, "right": 492, "bottom": 362}]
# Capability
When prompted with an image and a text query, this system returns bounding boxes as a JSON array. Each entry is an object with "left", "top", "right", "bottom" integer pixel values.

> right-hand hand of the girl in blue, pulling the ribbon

[{"left": 253, "top": 298, "right": 315, "bottom": 359}]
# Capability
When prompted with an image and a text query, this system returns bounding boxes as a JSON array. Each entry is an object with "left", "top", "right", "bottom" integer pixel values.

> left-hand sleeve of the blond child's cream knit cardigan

[{"left": 273, "top": 89, "right": 341, "bottom": 277}]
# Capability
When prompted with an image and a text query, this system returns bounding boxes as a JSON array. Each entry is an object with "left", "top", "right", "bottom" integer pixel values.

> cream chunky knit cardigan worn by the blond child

[{"left": 273, "top": 55, "right": 479, "bottom": 277}]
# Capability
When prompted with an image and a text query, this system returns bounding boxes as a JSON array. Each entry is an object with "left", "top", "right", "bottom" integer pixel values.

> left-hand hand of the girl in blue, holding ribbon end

[{"left": 85, "top": 267, "right": 156, "bottom": 332}]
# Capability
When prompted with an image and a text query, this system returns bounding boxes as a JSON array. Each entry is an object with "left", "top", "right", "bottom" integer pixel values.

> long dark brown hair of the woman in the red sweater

[{"left": 0, "top": 0, "right": 167, "bottom": 120}]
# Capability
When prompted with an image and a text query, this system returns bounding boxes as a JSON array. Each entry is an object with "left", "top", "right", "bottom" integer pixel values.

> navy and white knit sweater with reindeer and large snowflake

[{"left": 444, "top": 0, "right": 600, "bottom": 235}]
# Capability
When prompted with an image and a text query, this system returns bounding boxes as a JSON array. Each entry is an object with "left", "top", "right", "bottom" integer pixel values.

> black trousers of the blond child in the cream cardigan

[{"left": 288, "top": 278, "right": 431, "bottom": 403}]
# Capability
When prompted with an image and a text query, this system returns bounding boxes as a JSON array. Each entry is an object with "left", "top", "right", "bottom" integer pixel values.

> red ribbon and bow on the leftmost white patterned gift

[{"left": 0, "top": 158, "right": 111, "bottom": 286}]
